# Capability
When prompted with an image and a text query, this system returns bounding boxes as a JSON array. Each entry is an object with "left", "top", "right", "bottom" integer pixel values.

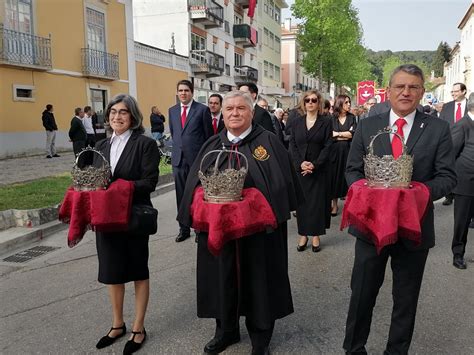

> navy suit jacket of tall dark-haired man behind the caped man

[{"left": 168, "top": 101, "right": 214, "bottom": 167}]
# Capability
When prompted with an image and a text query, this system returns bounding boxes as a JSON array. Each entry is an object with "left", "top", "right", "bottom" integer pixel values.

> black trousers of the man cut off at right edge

[{"left": 451, "top": 194, "right": 474, "bottom": 256}]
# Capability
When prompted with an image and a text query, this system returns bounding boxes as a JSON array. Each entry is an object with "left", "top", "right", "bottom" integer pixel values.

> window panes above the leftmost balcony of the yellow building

[{"left": 5, "top": 0, "right": 33, "bottom": 34}]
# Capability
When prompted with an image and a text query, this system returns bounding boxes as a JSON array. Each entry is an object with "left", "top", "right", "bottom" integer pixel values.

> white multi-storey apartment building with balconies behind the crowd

[{"left": 133, "top": 0, "right": 261, "bottom": 102}]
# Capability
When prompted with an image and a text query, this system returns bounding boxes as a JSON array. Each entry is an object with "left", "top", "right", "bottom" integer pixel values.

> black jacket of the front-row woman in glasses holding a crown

[{"left": 94, "top": 132, "right": 160, "bottom": 206}]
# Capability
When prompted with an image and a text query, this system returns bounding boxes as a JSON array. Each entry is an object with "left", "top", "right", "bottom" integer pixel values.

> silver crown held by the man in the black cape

[{"left": 198, "top": 145, "right": 248, "bottom": 203}]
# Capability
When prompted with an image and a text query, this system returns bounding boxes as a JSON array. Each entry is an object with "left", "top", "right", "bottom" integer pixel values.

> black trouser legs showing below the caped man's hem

[{"left": 215, "top": 317, "right": 275, "bottom": 348}]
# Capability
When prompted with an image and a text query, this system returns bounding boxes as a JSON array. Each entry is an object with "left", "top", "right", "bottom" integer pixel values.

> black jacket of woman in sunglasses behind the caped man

[{"left": 290, "top": 116, "right": 332, "bottom": 171}]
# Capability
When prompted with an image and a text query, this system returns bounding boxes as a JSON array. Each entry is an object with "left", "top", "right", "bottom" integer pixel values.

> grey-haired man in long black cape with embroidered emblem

[{"left": 178, "top": 91, "right": 303, "bottom": 354}]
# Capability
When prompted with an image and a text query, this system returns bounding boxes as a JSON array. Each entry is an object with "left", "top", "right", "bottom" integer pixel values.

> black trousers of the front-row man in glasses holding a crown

[{"left": 343, "top": 239, "right": 428, "bottom": 354}]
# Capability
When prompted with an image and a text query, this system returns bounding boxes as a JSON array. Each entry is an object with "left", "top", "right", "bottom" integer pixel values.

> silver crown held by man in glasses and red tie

[{"left": 364, "top": 127, "right": 413, "bottom": 188}]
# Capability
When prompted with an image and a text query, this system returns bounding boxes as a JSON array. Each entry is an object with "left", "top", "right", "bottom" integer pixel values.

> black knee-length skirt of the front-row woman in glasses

[{"left": 96, "top": 232, "right": 150, "bottom": 285}]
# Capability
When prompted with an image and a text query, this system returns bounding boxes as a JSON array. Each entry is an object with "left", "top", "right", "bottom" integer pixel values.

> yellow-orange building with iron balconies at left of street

[{"left": 0, "top": 0, "right": 136, "bottom": 158}]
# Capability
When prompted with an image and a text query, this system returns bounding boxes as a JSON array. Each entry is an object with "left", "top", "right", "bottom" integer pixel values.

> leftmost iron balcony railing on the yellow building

[{"left": 0, "top": 24, "right": 52, "bottom": 70}]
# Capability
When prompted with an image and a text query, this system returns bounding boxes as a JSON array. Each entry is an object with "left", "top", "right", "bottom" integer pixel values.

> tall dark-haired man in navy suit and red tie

[{"left": 168, "top": 80, "right": 214, "bottom": 242}]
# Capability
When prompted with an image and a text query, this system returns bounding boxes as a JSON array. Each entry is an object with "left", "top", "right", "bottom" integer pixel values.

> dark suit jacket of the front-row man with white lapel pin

[{"left": 346, "top": 112, "right": 456, "bottom": 250}]
